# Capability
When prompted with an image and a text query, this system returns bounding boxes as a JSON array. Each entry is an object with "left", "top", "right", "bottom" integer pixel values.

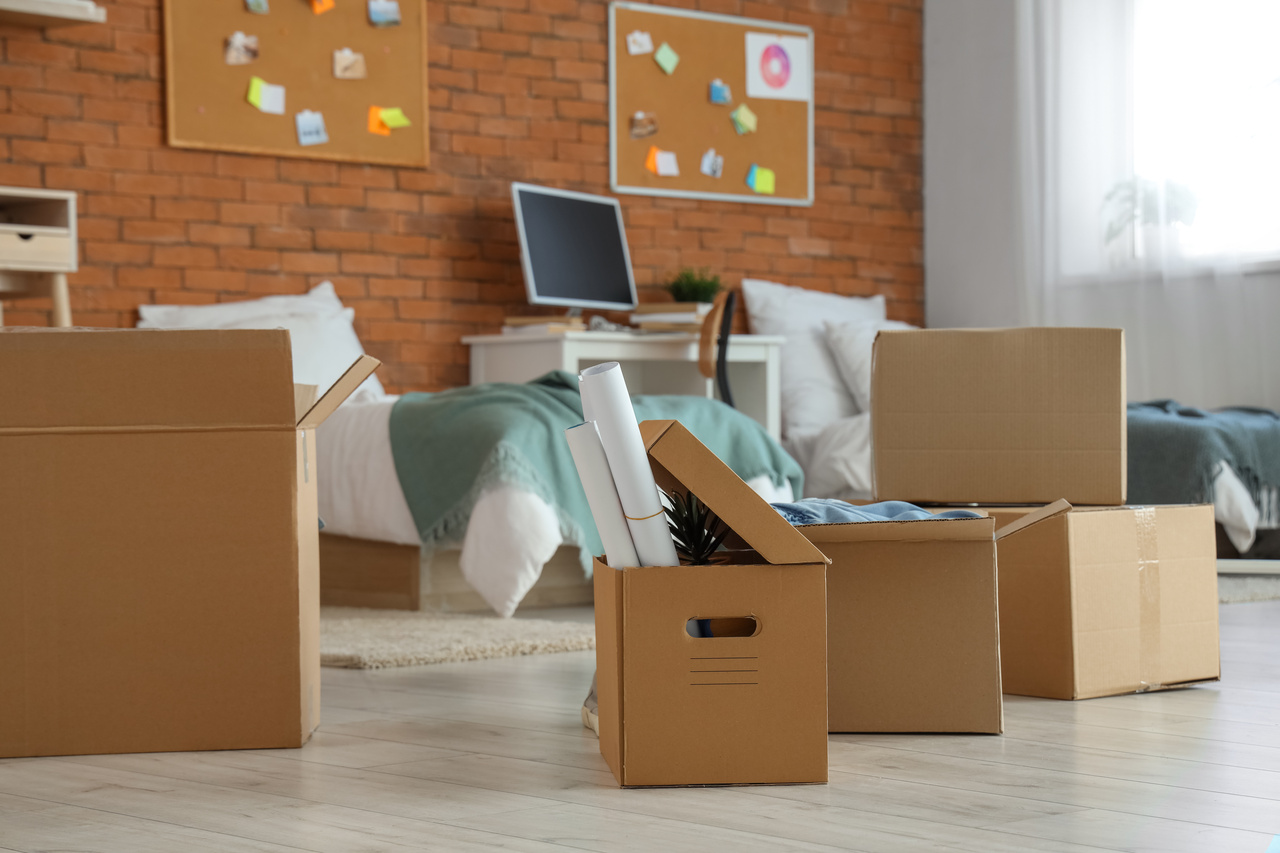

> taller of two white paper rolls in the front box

[{"left": 579, "top": 361, "right": 680, "bottom": 566}]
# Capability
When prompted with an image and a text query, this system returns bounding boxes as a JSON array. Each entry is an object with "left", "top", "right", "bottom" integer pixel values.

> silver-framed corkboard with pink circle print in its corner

[{"left": 609, "top": 0, "right": 814, "bottom": 205}]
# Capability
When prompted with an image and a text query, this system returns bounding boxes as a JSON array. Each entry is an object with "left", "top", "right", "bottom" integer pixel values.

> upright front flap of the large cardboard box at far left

[{"left": 0, "top": 329, "right": 294, "bottom": 432}]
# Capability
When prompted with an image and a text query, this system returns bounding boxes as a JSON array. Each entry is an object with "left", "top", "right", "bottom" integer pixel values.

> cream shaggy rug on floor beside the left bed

[{"left": 320, "top": 607, "right": 595, "bottom": 670}]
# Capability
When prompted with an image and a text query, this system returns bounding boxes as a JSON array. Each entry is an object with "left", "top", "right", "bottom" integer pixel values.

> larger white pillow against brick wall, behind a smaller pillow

[{"left": 742, "top": 278, "right": 884, "bottom": 435}]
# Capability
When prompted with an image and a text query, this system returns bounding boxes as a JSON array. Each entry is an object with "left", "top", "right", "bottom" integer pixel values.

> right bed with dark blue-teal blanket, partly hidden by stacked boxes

[{"left": 742, "top": 279, "right": 1280, "bottom": 560}]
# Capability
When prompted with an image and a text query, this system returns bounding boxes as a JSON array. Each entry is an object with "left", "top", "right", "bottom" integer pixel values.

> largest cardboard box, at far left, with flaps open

[{"left": 0, "top": 329, "right": 378, "bottom": 757}]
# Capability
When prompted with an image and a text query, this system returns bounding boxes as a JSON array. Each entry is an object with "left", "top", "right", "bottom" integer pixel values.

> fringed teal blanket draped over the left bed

[{"left": 390, "top": 370, "right": 804, "bottom": 567}]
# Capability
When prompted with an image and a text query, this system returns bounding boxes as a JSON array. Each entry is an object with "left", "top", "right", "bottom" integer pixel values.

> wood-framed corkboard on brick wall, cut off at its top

[{"left": 164, "top": 0, "right": 429, "bottom": 167}]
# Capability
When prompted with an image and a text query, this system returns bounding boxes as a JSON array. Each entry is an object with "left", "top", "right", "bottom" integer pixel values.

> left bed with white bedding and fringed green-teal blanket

[{"left": 138, "top": 282, "right": 803, "bottom": 616}]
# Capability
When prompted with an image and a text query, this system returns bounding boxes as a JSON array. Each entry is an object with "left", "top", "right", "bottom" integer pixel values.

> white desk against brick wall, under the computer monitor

[{"left": 462, "top": 332, "right": 783, "bottom": 439}]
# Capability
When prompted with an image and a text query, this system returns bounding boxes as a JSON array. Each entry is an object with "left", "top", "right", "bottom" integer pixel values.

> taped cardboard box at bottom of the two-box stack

[{"left": 996, "top": 501, "right": 1220, "bottom": 699}]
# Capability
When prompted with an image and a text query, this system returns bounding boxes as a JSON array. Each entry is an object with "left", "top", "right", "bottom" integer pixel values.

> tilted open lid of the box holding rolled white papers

[{"left": 640, "top": 420, "right": 831, "bottom": 565}]
